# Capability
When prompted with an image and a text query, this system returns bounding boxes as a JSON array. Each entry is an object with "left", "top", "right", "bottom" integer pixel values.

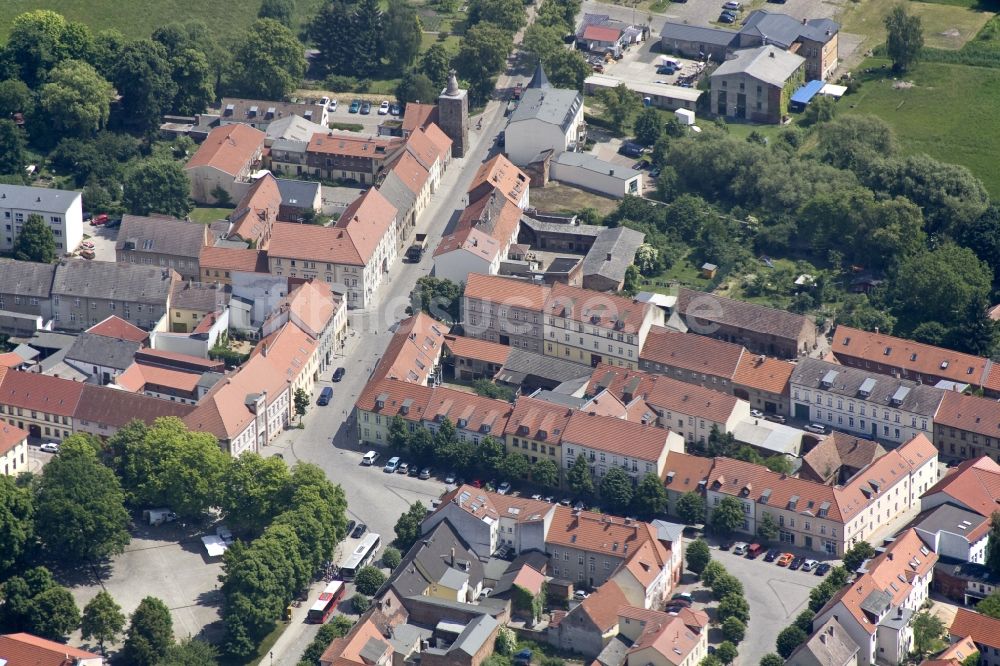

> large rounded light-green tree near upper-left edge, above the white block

[{"left": 32, "top": 60, "right": 115, "bottom": 143}]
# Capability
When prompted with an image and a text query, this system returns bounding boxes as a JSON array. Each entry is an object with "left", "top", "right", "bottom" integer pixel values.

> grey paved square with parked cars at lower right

[{"left": 678, "top": 542, "right": 834, "bottom": 665}]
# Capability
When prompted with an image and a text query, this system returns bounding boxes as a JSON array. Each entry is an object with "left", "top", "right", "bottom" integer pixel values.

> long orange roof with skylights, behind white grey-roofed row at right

[{"left": 830, "top": 325, "right": 990, "bottom": 385}]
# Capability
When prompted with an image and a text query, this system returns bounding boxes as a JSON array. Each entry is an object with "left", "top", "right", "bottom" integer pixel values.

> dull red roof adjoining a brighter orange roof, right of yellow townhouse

[{"left": 639, "top": 326, "right": 748, "bottom": 380}]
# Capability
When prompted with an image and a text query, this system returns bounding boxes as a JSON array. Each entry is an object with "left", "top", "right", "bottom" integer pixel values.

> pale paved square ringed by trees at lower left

[{"left": 68, "top": 523, "right": 228, "bottom": 643}]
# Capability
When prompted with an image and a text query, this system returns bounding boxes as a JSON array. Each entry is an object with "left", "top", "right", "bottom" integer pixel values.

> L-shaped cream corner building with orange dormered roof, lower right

[{"left": 696, "top": 435, "right": 937, "bottom": 556}]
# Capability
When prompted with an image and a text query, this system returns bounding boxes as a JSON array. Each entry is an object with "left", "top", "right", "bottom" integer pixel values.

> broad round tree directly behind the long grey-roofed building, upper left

[{"left": 229, "top": 19, "right": 306, "bottom": 99}]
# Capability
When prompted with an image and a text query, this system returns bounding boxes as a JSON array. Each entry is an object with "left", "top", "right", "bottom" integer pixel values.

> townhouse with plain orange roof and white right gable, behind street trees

[{"left": 560, "top": 411, "right": 684, "bottom": 485}]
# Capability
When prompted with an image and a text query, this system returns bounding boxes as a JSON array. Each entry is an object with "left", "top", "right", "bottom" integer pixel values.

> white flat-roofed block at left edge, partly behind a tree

[{"left": 0, "top": 184, "right": 83, "bottom": 255}]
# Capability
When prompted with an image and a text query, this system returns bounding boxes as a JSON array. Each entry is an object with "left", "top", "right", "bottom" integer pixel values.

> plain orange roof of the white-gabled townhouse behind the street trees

[{"left": 563, "top": 412, "right": 670, "bottom": 461}]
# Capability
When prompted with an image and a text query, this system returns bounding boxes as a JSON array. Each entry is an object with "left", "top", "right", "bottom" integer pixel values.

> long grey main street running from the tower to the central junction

[{"left": 262, "top": 61, "right": 525, "bottom": 666}]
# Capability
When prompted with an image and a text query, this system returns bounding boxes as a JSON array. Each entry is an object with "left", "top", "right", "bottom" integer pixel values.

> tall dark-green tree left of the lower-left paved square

[{"left": 35, "top": 435, "right": 129, "bottom": 562}]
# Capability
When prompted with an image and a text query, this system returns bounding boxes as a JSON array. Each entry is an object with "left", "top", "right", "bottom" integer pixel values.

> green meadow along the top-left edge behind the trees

[{"left": 0, "top": 0, "right": 323, "bottom": 42}]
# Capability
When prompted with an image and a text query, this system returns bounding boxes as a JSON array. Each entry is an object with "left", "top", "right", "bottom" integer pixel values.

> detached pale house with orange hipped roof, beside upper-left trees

[{"left": 184, "top": 124, "right": 266, "bottom": 204}]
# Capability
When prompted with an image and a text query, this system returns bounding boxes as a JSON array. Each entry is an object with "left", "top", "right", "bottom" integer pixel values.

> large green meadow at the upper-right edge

[{"left": 840, "top": 59, "right": 1000, "bottom": 198}]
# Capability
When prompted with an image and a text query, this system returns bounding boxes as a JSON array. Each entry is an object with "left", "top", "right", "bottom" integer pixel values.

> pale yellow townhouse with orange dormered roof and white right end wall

[{"left": 543, "top": 283, "right": 663, "bottom": 370}]
